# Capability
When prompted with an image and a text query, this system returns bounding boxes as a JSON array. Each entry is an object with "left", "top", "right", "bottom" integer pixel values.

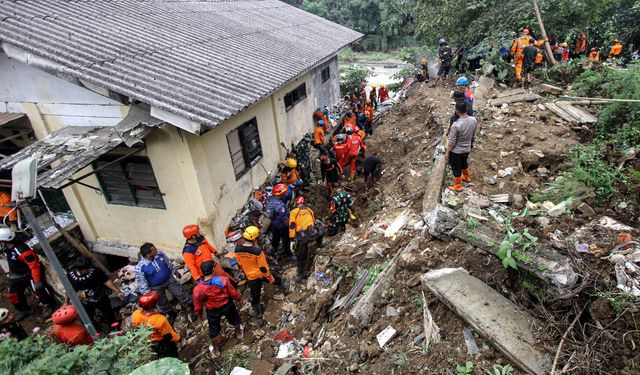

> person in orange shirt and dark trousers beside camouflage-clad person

[{"left": 289, "top": 197, "right": 322, "bottom": 283}]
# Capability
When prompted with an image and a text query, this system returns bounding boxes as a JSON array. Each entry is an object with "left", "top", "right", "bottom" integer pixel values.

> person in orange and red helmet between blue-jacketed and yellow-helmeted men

[{"left": 180, "top": 224, "right": 232, "bottom": 282}]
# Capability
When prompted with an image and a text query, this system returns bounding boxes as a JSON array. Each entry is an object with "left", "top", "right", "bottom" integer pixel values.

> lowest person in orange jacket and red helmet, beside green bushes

[{"left": 131, "top": 291, "right": 180, "bottom": 358}]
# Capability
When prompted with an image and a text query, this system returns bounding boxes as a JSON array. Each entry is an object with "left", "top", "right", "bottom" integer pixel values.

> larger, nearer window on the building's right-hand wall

[{"left": 227, "top": 117, "right": 262, "bottom": 180}]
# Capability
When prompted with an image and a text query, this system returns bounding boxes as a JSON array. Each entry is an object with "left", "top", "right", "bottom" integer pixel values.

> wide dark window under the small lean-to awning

[{"left": 93, "top": 155, "right": 165, "bottom": 208}]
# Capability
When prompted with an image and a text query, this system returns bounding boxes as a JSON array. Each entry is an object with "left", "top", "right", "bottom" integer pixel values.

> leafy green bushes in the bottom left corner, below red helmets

[{"left": 0, "top": 328, "right": 152, "bottom": 375}]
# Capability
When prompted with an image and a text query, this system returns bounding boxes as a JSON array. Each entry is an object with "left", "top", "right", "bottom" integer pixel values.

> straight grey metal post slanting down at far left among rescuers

[{"left": 20, "top": 204, "right": 97, "bottom": 337}]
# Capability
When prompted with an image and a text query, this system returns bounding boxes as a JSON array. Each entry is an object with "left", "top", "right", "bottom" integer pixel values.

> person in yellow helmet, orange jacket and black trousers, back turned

[{"left": 235, "top": 226, "right": 282, "bottom": 317}]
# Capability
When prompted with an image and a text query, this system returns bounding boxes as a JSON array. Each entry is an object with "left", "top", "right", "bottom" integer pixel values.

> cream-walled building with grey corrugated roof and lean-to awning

[{"left": 0, "top": 0, "right": 362, "bottom": 257}]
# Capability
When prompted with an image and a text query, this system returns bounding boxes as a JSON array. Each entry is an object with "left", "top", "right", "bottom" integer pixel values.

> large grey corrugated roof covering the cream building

[{"left": 0, "top": 0, "right": 362, "bottom": 132}]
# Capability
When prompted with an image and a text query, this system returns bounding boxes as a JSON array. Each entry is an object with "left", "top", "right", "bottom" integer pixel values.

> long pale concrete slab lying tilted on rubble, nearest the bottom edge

[{"left": 421, "top": 268, "right": 551, "bottom": 375}]
